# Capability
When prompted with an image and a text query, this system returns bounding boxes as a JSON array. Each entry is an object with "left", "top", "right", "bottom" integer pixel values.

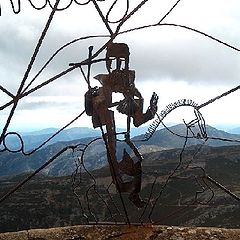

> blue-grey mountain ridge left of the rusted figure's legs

[{"left": 0, "top": 138, "right": 107, "bottom": 176}]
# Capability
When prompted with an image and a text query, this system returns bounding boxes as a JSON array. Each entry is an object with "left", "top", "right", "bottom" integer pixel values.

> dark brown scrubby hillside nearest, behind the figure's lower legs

[{"left": 0, "top": 143, "right": 240, "bottom": 232}]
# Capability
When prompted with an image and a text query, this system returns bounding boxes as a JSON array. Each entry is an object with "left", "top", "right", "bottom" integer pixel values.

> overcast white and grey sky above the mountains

[{"left": 0, "top": 0, "right": 240, "bottom": 131}]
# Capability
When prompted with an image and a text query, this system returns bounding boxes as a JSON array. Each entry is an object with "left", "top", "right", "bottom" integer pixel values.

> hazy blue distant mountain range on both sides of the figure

[{"left": 0, "top": 125, "right": 240, "bottom": 177}]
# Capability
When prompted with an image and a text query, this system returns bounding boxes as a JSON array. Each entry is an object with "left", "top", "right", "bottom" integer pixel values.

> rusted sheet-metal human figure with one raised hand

[{"left": 85, "top": 43, "right": 158, "bottom": 208}]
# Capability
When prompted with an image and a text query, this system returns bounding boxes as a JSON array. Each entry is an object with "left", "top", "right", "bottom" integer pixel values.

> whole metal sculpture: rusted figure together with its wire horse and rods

[{"left": 0, "top": 0, "right": 240, "bottom": 229}]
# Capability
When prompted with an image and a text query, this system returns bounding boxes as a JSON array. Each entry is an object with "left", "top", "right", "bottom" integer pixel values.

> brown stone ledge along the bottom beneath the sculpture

[{"left": 0, "top": 224, "right": 240, "bottom": 240}]
